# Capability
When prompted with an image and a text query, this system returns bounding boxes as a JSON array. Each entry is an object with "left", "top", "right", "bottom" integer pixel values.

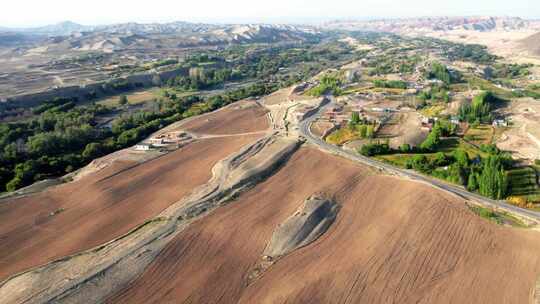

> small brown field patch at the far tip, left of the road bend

[{"left": 182, "top": 101, "right": 269, "bottom": 135}]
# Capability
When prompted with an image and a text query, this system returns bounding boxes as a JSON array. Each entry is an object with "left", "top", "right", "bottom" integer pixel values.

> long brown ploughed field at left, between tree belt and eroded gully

[{"left": 0, "top": 136, "right": 259, "bottom": 280}]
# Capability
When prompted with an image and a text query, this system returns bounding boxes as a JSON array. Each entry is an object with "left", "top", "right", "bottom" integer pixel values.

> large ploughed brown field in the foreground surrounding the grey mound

[{"left": 106, "top": 149, "right": 540, "bottom": 303}]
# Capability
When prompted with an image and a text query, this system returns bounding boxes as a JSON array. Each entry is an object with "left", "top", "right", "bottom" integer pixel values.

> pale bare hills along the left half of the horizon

[{"left": 0, "top": 21, "right": 320, "bottom": 52}]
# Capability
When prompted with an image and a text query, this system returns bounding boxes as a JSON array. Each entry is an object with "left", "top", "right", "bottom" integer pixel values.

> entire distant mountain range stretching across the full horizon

[{"left": 0, "top": 17, "right": 540, "bottom": 52}]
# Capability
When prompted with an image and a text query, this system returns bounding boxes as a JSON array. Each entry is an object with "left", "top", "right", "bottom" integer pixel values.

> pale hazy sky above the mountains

[{"left": 0, "top": 0, "right": 540, "bottom": 26}]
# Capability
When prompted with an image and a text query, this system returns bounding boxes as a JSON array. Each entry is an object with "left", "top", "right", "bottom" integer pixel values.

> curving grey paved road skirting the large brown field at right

[{"left": 299, "top": 97, "right": 540, "bottom": 222}]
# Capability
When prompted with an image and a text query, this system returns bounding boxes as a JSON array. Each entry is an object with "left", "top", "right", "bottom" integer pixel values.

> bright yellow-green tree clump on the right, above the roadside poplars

[{"left": 458, "top": 91, "right": 500, "bottom": 123}]
